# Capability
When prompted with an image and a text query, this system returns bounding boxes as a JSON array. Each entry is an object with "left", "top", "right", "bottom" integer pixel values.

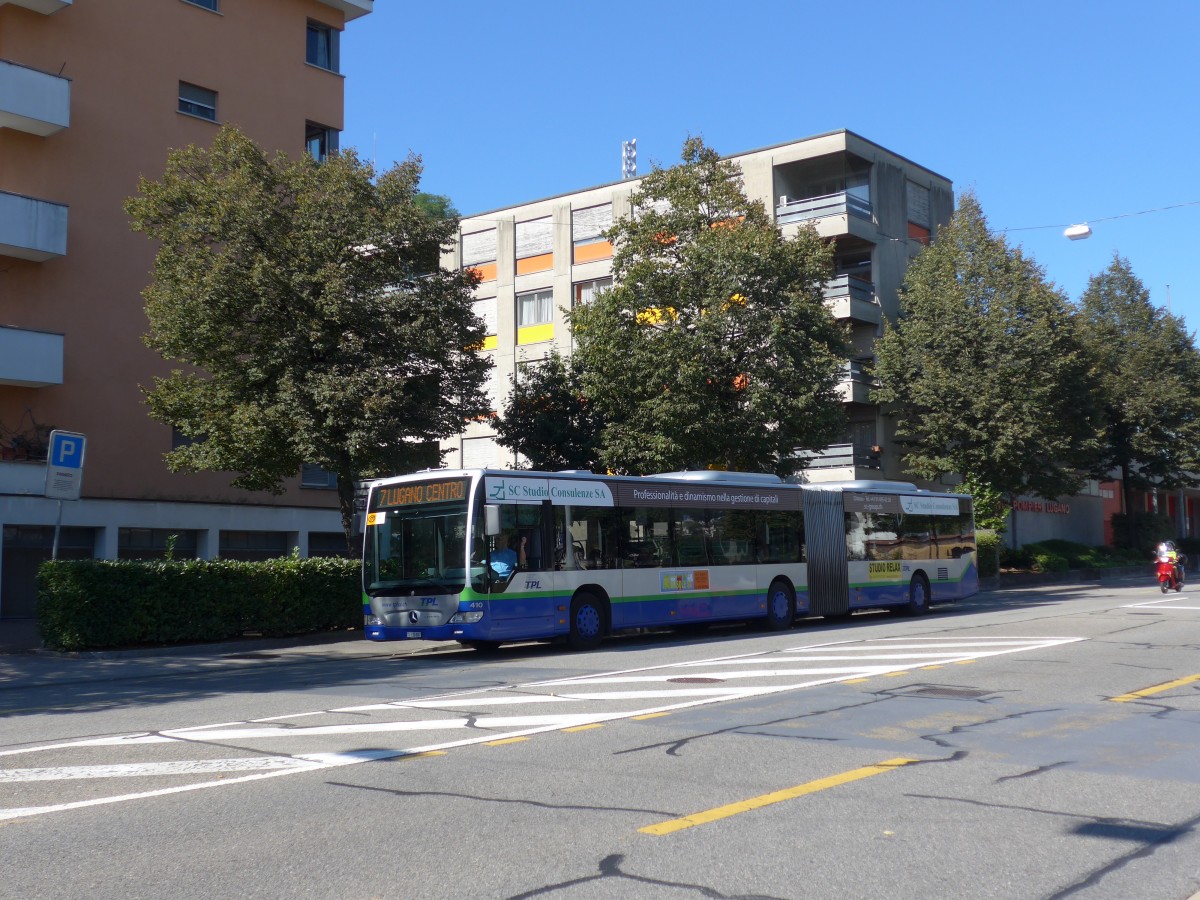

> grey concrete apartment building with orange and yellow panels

[{"left": 443, "top": 131, "right": 954, "bottom": 481}]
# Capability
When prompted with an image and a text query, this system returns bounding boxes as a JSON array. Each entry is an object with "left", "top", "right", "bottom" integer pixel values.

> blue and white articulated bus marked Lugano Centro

[{"left": 362, "top": 469, "right": 979, "bottom": 649}]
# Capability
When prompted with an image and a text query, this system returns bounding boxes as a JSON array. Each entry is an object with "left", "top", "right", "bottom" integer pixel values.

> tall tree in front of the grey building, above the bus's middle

[{"left": 569, "top": 138, "right": 845, "bottom": 474}]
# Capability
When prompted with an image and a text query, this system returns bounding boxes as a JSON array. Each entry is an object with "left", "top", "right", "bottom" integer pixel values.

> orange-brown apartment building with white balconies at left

[{"left": 0, "top": 0, "right": 372, "bottom": 618}]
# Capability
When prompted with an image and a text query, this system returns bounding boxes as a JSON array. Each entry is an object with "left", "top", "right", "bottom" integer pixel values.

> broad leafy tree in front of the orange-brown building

[{"left": 125, "top": 127, "right": 491, "bottom": 554}]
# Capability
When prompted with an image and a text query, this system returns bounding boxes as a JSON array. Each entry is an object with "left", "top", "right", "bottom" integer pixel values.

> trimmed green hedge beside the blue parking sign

[{"left": 37, "top": 557, "right": 362, "bottom": 650}]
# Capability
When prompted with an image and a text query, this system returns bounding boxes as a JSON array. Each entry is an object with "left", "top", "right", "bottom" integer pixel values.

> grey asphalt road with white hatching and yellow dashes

[{"left": 0, "top": 578, "right": 1200, "bottom": 900}]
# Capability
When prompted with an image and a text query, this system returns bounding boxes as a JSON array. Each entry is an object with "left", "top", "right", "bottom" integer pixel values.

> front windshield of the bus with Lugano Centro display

[{"left": 364, "top": 479, "right": 467, "bottom": 595}]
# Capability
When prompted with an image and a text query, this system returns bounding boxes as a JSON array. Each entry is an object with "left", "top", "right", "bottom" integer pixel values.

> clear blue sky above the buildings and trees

[{"left": 342, "top": 0, "right": 1200, "bottom": 330}]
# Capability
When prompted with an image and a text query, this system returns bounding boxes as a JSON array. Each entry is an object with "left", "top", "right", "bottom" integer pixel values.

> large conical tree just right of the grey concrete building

[{"left": 874, "top": 193, "right": 1100, "bottom": 542}]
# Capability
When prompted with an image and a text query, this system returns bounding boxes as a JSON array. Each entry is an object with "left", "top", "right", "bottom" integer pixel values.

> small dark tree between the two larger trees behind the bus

[{"left": 494, "top": 350, "right": 602, "bottom": 470}]
